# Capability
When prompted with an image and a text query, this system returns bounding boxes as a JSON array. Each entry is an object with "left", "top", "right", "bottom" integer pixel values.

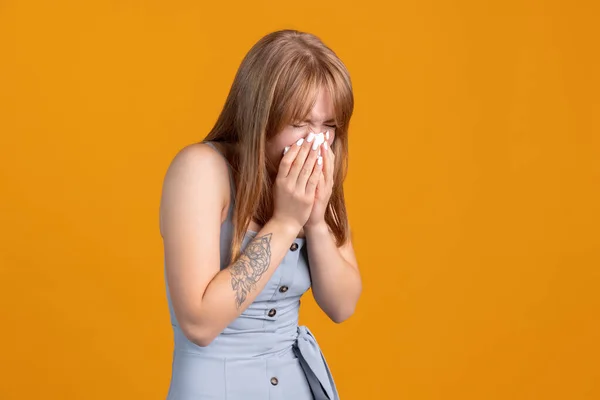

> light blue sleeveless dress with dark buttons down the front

[{"left": 164, "top": 142, "right": 339, "bottom": 400}]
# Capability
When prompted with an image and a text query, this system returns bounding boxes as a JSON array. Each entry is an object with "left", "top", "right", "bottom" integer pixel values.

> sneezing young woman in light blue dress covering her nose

[{"left": 160, "top": 30, "right": 362, "bottom": 400}]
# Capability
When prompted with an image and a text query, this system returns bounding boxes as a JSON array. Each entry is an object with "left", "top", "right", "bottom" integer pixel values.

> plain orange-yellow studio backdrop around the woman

[{"left": 0, "top": 0, "right": 600, "bottom": 400}]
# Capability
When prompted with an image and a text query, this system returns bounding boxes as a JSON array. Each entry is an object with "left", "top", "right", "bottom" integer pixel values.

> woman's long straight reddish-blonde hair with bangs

[{"left": 204, "top": 30, "right": 354, "bottom": 262}]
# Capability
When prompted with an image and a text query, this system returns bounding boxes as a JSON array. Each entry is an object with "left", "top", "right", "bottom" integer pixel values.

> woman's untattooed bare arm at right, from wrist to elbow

[{"left": 304, "top": 222, "right": 362, "bottom": 323}]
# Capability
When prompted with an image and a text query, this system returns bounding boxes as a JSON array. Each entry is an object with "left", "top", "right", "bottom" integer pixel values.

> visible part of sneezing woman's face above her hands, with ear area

[{"left": 266, "top": 88, "right": 335, "bottom": 173}]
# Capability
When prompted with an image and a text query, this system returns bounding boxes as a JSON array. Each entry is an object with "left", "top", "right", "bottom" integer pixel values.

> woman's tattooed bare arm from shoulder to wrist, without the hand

[{"left": 161, "top": 145, "right": 301, "bottom": 346}]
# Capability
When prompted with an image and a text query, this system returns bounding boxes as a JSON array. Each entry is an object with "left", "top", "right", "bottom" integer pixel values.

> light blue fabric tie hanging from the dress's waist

[{"left": 297, "top": 325, "right": 339, "bottom": 400}]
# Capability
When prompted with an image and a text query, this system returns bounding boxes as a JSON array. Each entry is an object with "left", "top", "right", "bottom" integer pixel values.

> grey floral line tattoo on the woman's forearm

[{"left": 230, "top": 233, "right": 273, "bottom": 309}]
